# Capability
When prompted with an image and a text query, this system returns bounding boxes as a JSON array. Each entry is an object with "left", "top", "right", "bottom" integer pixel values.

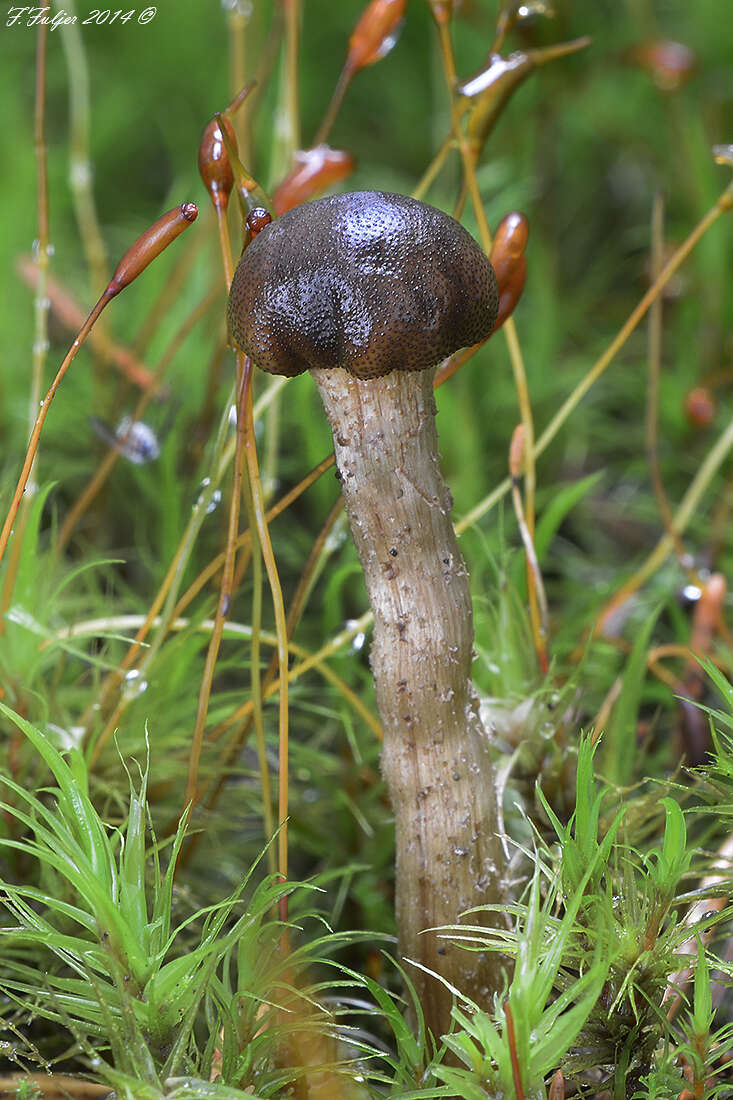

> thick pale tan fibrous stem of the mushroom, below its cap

[{"left": 313, "top": 370, "right": 503, "bottom": 1035}]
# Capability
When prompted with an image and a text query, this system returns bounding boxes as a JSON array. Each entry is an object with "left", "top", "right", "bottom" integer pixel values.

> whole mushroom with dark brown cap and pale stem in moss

[{"left": 229, "top": 191, "right": 503, "bottom": 1034}]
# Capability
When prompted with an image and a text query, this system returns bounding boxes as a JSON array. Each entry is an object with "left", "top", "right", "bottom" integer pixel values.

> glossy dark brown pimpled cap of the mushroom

[{"left": 229, "top": 191, "right": 499, "bottom": 378}]
